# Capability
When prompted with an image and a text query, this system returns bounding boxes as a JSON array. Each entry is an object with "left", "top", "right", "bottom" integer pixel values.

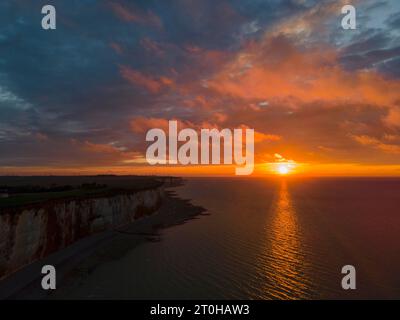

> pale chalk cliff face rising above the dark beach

[{"left": 0, "top": 187, "right": 164, "bottom": 279}]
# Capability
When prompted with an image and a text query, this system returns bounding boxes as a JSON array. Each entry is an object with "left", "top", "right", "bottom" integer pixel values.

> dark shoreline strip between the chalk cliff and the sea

[{"left": 0, "top": 188, "right": 208, "bottom": 299}]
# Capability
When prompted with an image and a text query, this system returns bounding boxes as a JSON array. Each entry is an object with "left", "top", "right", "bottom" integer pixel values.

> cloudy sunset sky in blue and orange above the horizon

[{"left": 0, "top": 0, "right": 400, "bottom": 176}]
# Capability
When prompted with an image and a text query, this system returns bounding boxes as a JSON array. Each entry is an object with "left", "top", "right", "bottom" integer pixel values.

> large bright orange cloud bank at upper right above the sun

[{"left": 207, "top": 36, "right": 400, "bottom": 116}]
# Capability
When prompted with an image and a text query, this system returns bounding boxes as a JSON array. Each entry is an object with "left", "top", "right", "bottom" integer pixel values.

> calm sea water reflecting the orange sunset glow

[{"left": 58, "top": 178, "right": 400, "bottom": 299}]
